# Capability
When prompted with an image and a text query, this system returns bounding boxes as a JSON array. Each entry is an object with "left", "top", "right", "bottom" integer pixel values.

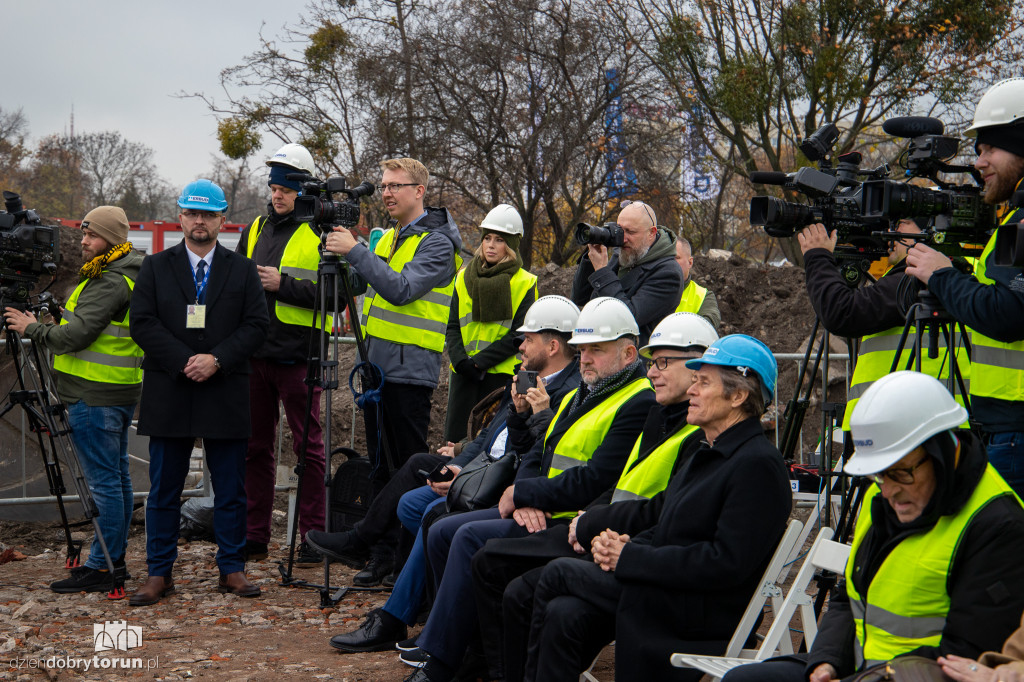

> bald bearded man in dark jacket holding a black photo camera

[{"left": 570, "top": 202, "right": 683, "bottom": 345}]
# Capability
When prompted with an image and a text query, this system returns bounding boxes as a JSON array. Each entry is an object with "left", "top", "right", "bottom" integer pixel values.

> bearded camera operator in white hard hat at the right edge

[{"left": 907, "top": 78, "right": 1024, "bottom": 496}]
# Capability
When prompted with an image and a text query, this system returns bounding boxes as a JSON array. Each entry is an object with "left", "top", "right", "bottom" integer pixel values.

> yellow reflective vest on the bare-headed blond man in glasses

[{"left": 360, "top": 227, "right": 462, "bottom": 353}]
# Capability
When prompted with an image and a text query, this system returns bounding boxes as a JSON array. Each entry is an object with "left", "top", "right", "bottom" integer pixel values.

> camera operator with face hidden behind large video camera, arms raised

[{"left": 797, "top": 218, "right": 969, "bottom": 430}]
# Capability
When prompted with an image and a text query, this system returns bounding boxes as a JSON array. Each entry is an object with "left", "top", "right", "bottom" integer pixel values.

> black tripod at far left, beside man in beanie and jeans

[{"left": 0, "top": 305, "right": 125, "bottom": 599}]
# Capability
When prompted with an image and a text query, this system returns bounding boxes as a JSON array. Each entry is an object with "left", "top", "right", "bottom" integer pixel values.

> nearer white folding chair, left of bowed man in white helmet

[{"left": 671, "top": 527, "right": 850, "bottom": 682}]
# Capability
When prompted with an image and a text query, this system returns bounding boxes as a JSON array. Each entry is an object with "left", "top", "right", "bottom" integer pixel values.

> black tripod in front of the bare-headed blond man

[{"left": 279, "top": 240, "right": 394, "bottom": 607}]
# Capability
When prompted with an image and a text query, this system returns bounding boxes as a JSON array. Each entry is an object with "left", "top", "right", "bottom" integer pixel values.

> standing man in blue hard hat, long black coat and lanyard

[{"left": 129, "top": 180, "right": 268, "bottom": 606}]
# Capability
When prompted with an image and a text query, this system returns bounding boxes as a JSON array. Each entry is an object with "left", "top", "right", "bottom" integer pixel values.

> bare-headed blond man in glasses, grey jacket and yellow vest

[{"left": 325, "top": 159, "right": 462, "bottom": 584}]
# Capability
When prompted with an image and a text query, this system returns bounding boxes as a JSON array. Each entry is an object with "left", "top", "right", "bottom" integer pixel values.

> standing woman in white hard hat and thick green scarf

[{"left": 444, "top": 204, "right": 537, "bottom": 442}]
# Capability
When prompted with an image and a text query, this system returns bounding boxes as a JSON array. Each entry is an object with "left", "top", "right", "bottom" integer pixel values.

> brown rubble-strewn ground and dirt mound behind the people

[{"left": 0, "top": 235, "right": 843, "bottom": 680}]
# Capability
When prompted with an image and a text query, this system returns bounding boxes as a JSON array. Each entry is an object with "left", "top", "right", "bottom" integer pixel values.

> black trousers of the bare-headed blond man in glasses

[{"left": 362, "top": 382, "right": 434, "bottom": 495}]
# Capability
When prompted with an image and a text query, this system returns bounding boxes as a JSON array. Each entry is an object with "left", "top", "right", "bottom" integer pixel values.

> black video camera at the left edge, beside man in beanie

[{"left": 0, "top": 191, "right": 60, "bottom": 310}]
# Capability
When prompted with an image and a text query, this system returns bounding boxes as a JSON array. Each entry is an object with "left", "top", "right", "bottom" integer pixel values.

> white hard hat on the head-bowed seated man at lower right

[{"left": 845, "top": 372, "right": 968, "bottom": 476}]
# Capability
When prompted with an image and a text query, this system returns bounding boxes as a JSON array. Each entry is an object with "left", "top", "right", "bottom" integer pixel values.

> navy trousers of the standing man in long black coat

[{"left": 145, "top": 436, "right": 246, "bottom": 578}]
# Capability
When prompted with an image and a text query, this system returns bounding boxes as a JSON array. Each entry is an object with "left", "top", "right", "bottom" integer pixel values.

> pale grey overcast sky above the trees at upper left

[{"left": 7, "top": 0, "right": 302, "bottom": 188}]
